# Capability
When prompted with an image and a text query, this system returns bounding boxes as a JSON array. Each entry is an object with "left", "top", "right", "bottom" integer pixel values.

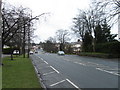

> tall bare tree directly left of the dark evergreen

[{"left": 72, "top": 4, "right": 109, "bottom": 51}]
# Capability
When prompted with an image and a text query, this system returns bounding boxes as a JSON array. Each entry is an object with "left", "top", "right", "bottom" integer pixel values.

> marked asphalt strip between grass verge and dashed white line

[{"left": 30, "top": 55, "right": 81, "bottom": 90}]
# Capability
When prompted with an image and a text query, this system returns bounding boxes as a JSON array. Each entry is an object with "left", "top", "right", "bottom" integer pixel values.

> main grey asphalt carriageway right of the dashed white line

[{"left": 32, "top": 52, "right": 120, "bottom": 88}]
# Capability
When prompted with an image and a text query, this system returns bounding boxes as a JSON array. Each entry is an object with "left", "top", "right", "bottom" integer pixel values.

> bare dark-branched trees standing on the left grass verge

[{"left": 2, "top": 2, "right": 48, "bottom": 57}]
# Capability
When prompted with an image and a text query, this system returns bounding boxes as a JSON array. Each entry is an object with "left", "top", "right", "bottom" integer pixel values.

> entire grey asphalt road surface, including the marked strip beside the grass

[{"left": 30, "top": 52, "right": 120, "bottom": 90}]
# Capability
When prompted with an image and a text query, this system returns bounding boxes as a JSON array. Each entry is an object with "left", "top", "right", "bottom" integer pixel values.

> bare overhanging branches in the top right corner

[{"left": 93, "top": 0, "right": 120, "bottom": 21}]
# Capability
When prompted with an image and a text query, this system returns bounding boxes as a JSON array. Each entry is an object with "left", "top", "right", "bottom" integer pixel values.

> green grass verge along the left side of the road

[{"left": 2, "top": 56, "right": 41, "bottom": 88}]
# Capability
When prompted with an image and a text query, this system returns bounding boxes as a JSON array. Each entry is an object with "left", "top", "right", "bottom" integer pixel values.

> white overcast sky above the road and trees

[{"left": 4, "top": 0, "right": 117, "bottom": 43}]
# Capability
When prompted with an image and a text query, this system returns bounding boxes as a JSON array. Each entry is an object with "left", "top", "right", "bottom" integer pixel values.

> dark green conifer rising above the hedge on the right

[{"left": 94, "top": 19, "right": 117, "bottom": 44}]
